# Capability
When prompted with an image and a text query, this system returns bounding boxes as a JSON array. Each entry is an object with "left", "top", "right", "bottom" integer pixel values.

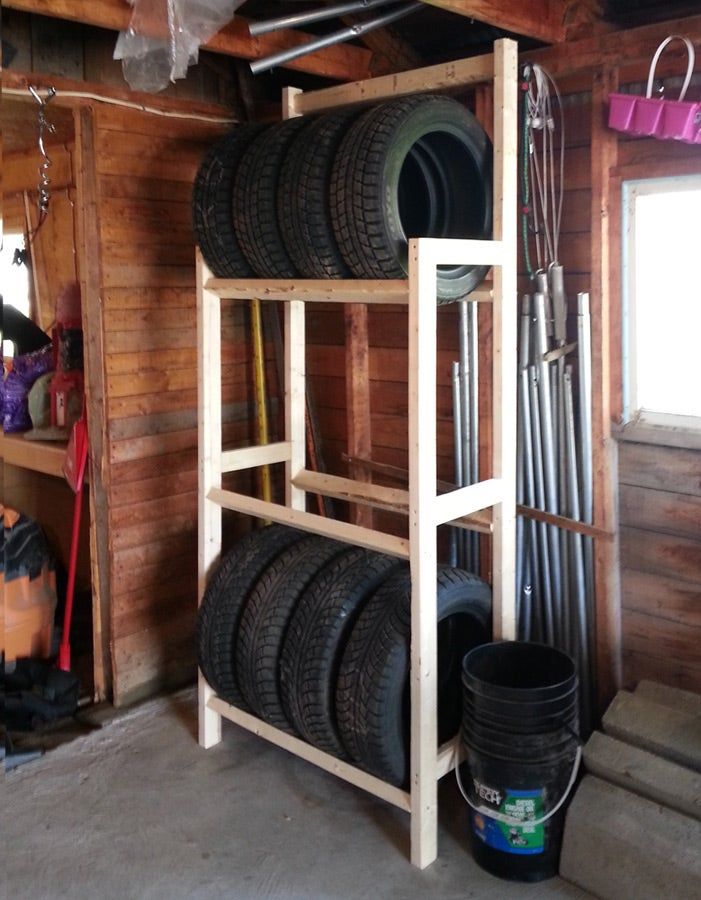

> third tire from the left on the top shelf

[{"left": 278, "top": 109, "right": 361, "bottom": 278}]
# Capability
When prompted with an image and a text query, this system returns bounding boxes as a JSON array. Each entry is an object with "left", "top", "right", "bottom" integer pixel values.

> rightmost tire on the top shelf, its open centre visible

[{"left": 331, "top": 95, "right": 492, "bottom": 303}]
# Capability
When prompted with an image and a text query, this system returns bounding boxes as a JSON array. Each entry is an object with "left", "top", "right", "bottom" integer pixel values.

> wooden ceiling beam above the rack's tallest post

[{"left": 424, "top": 0, "right": 567, "bottom": 44}]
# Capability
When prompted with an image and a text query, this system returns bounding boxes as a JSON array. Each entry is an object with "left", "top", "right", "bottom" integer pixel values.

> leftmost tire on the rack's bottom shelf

[{"left": 197, "top": 525, "right": 304, "bottom": 709}]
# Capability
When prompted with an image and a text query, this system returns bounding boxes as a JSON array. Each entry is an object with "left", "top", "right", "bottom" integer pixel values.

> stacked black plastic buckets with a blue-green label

[{"left": 461, "top": 641, "right": 581, "bottom": 881}]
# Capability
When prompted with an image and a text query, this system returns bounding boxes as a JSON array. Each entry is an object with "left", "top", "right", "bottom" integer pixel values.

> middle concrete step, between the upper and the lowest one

[{"left": 584, "top": 731, "right": 701, "bottom": 820}]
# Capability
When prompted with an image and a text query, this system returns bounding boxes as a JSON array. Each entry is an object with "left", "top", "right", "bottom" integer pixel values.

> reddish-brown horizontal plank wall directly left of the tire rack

[{"left": 85, "top": 107, "right": 258, "bottom": 705}]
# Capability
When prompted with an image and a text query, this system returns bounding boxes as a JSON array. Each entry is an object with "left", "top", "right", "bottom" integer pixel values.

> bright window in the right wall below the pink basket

[{"left": 623, "top": 175, "right": 701, "bottom": 429}]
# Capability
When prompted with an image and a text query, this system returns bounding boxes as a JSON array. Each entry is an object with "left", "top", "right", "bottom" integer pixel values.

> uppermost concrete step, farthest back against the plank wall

[{"left": 602, "top": 691, "right": 701, "bottom": 772}]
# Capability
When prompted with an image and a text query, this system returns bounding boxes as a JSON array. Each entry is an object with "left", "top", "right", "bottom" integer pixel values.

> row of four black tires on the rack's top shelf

[{"left": 193, "top": 95, "right": 492, "bottom": 303}]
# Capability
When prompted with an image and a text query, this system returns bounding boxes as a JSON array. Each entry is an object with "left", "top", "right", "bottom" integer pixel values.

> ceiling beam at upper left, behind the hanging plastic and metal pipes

[{"left": 4, "top": 0, "right": 372, "bottom": 81}]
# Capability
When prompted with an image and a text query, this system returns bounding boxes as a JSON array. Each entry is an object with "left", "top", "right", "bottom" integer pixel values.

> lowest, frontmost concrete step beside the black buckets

[{"left": 560, "top": 775, "right": 701, "bottom": 900}]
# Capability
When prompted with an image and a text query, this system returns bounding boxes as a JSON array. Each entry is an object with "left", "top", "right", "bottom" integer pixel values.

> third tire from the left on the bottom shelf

[{"left": 280, "top": 547, "right": 402, "bottom": 757}]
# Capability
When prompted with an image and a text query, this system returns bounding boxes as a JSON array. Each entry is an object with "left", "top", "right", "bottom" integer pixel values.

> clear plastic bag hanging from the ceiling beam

[{"left": 114, "top": 0, "right": 243, "bottom": 94}]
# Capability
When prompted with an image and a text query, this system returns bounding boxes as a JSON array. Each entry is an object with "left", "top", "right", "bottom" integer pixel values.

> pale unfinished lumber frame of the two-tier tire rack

[{"left": 197, "top": 40, "right": 517, "bottom": 868}]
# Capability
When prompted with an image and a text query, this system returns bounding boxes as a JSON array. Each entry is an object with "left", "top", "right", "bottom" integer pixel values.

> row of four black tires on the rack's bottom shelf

[{"left": 197, "top": 525, "right": 491, "bottom": 787}]
